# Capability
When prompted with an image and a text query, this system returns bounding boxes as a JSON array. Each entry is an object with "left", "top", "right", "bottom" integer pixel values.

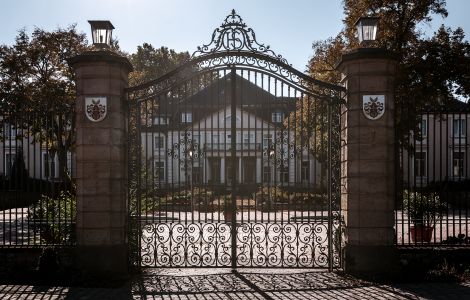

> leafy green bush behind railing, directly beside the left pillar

[{"left": 28, "top": 191, "right": 77, "bottom": 245}]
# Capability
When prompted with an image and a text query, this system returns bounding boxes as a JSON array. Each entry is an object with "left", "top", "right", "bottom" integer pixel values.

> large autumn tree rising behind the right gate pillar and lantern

[{"left": 308, "top": 0, "right": 470, "bottom": 143}]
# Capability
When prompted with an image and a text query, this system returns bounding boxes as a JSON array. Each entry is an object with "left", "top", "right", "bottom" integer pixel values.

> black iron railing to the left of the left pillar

[{"left": 0, "top": 111, "right": 76, "bottom": 248}]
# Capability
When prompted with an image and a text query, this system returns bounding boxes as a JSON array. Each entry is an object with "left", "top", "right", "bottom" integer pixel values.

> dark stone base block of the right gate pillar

[{"left": 344, "top": 245, "right": 399, "bottom": 278}]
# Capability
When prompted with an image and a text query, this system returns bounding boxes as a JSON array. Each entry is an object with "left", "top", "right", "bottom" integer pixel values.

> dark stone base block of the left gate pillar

[{"left": 76, "top": 245, "right": 129, "bottom": 280}]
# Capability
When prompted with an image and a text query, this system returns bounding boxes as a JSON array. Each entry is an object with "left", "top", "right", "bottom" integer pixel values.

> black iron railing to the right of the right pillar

[{"left": 395, "top": 108, "right": 470, "bottom": 247}]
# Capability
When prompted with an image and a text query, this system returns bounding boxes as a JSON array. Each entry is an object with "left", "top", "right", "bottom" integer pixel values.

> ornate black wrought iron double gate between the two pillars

[{"left": 128, "top": 11, "right": 343, "bottom": 269}]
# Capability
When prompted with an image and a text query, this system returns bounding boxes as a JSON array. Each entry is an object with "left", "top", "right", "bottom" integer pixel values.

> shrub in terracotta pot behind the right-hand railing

[{"left": 403, "top": 191, "right": 446, "bottom": 243}]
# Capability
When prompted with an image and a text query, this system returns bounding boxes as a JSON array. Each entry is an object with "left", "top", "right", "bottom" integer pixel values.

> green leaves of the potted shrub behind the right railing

[{"left": 403, "top": 190, "right": 446, "bottom": 226}]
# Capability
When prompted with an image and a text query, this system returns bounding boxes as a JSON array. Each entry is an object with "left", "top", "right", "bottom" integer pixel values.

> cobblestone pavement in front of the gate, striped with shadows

[{"left": 0, "top": 269, "right": 470, "bottom": 300}]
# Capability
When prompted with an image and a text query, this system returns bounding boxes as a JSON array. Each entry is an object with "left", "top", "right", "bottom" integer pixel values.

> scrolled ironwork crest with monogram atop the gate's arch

[{"left": 192, "top": 9, "right": 288, "bottom": 64}]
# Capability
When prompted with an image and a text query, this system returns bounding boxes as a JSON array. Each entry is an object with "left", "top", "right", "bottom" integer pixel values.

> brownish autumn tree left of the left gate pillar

[{"left": 0, "top": 26, "right": 87, "bottom": 180}]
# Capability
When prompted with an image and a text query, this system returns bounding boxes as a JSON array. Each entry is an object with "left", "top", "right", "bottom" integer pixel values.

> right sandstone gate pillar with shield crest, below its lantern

[{"left": 337, "top": 48, "right": 397, "bottom": 273}]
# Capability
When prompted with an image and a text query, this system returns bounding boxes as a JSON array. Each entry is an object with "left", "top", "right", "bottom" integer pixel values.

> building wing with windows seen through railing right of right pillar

[{"left": 401, "top": 100, "right": 470, "bottom": 187}]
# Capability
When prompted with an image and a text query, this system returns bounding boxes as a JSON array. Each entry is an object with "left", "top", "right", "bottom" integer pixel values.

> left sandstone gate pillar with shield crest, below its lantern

[{"left": 69, "top": 51, "right": 132, "bottom": 276}]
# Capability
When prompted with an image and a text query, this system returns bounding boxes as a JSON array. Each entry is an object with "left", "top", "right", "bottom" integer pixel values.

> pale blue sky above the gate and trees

[{"left": 0, "top": 0, "right": 470, "bottom": 71}]
